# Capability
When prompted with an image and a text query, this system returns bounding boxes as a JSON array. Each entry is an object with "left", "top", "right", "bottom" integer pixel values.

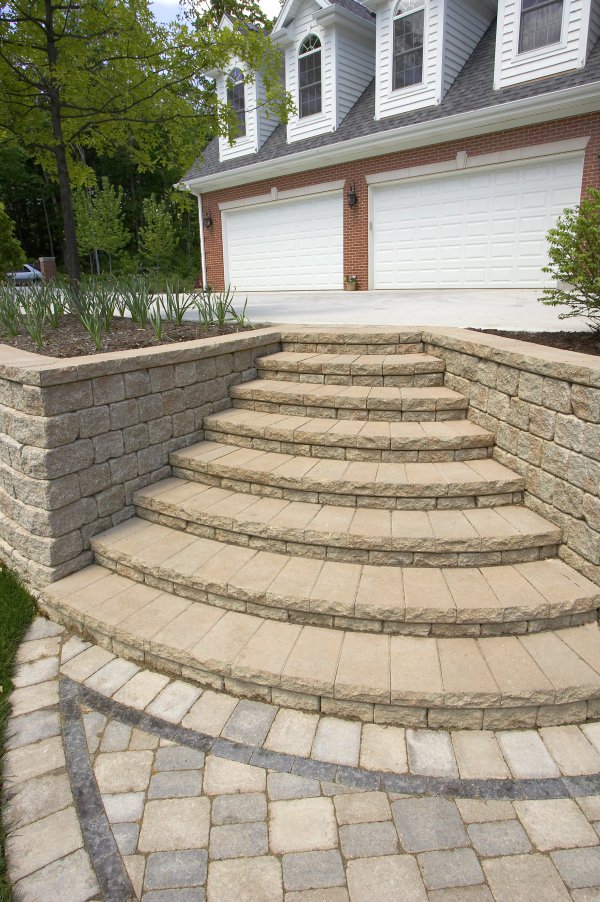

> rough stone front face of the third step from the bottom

[{"left": 134, "top": 498, "right": 558, "bottom": 567}]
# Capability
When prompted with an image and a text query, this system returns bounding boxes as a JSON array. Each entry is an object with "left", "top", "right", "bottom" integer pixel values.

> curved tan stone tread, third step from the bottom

[{"left": 134, "top": 478, "right": 562, "bottom": 553}]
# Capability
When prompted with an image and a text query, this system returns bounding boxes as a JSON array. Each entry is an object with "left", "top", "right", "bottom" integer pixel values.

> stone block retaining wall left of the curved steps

[{"left": 0, "top": 329, "right": 280, "bottom": 587}]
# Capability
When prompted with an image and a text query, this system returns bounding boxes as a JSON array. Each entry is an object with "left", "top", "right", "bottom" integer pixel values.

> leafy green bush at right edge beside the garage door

[{"left": 542, "top": 188, "right": 600, "bottom": 332}]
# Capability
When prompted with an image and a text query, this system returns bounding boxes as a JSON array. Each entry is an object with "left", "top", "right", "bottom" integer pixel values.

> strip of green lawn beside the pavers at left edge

[{"left": 0, "top": 570, "right": 35, "bottom": 902}]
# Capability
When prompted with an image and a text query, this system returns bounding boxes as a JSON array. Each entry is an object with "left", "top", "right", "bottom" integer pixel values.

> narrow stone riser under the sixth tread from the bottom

[{"left": 233, "top": 398, "right": 467, "bottom": 423}]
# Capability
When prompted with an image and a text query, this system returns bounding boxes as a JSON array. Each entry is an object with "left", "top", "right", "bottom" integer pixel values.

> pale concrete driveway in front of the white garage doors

[{"left": 236, "top": 289, "right": 587, "bottom": 332}]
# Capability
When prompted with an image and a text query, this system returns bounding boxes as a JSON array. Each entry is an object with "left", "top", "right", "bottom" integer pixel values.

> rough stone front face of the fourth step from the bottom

[{"left": 172, "top": 459, "right": 523, "bottom": 510}]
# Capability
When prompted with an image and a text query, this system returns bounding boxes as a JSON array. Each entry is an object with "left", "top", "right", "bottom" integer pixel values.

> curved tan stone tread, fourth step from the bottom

[{"left": 170, "top": 441, "right": 524, "bottom": 497}]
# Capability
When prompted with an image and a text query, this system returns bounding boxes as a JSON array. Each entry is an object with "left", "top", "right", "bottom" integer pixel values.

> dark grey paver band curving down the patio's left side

[{"left": 59, "top": 679, "right": 136, "bottom": 902}]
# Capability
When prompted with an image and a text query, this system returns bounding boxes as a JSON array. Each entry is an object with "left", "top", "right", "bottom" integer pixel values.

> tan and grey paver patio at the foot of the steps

[{"left": 4, "top": 619, "right": 600, "bottom": 902}]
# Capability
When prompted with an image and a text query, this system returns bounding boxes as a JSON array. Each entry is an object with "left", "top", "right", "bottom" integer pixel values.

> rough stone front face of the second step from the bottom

[{"left": 88, "top": 548, "right": 597, "bottom": 638}]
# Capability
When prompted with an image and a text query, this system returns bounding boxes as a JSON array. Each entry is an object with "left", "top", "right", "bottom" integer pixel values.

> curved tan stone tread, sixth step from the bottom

[{"left": 230, "top": 379, "right": 468, "bottom": 411}]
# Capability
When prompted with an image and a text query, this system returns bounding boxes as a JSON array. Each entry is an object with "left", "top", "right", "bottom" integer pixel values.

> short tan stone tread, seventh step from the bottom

[{"left": 256, "top": 351, "right": 445, "bottom": 376}]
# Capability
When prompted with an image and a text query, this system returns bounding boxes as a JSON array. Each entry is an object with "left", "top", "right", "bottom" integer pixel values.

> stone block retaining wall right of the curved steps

[{"left": 423, "top": 329, "right": 600, "bottom": 584}]
